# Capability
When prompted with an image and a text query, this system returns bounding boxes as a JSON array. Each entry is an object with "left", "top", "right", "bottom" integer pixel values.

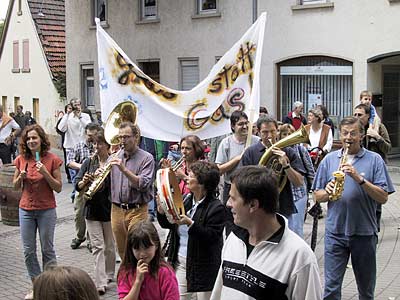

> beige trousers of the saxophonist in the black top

[{"left": 86, "top": 220, "right": 115, "bottom": 288}]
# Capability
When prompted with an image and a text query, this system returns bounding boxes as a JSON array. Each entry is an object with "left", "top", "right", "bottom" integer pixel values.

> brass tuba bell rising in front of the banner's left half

[{"left": 104, "top": 101, "right": 137, "bottom": 146}]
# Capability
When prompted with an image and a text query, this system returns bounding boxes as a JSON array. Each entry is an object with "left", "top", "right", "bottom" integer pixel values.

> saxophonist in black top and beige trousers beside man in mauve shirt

[{"left": 76, "top": 130, "right": 115, "bottom": 294}]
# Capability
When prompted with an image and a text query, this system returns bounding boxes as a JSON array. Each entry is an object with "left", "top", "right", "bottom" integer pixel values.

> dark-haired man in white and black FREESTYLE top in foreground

[{"left": 211, "top": 166, "right": 322, "bottom": 300}]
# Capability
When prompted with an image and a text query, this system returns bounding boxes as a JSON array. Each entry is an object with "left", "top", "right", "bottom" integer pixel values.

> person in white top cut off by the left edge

[{"left": 0, "top": 105, "right": 21, "bottom": 164}]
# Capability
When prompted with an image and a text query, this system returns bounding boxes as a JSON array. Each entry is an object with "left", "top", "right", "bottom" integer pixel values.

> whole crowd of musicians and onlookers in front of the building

[{"left": 0, "top": 91, "right": 394, "bottom": 300}]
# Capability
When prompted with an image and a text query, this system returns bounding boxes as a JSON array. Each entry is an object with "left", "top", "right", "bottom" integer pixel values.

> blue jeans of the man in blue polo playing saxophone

[{"left": 324, "top": 231, "right": 378, "bottom": 300}]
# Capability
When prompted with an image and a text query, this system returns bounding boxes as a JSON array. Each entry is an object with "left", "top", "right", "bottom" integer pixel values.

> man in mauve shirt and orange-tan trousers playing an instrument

[{"left": 110, "top": 122, "right": 155, "bottom": 259}]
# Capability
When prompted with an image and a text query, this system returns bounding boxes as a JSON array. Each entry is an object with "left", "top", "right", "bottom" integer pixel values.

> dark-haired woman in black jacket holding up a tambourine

[{"left": 157, "top": 161, "right": 226, "bottom": 300}]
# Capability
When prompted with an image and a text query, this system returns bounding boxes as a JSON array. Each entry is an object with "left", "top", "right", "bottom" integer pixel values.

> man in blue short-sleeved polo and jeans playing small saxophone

[{"left": 312, "top": 117, "right": 394, "bottom": 299}]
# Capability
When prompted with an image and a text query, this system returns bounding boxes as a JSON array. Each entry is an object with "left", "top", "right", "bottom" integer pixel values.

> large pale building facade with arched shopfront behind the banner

[{"left": 66, "top": 0, "right": 400, "bottom": 153}]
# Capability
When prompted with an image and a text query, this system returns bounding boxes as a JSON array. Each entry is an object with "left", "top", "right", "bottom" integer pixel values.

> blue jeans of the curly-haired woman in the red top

[{"left": 19, "top": 208, "right": 57, "bottom": 279}]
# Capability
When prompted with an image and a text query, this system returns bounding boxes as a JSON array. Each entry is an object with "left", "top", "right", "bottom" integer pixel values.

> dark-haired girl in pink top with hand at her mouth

[{"left": 117, "top": 221, "right": 179, "bottom": 300}]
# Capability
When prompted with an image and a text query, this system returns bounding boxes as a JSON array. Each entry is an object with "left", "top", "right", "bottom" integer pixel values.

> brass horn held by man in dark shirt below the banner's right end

[{"left": 258, "top": 125, "right": 310, "bottom": 192}]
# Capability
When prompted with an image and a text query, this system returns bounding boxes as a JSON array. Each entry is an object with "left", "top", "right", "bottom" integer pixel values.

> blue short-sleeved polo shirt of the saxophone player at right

[{"left": 312, "top": 148, "right": 395, "bottom": 236}]
